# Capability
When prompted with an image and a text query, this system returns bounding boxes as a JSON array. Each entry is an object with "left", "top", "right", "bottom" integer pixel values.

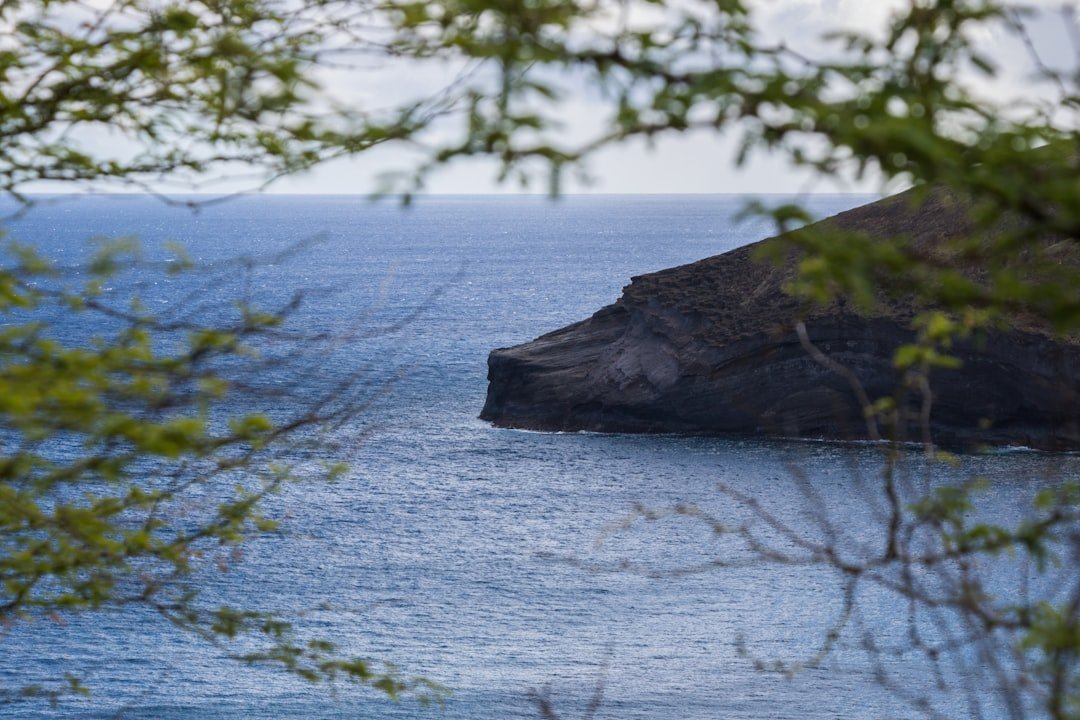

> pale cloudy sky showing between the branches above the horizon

[{"left": 28, "top": 0, "right": 1080, "bottom": 194}]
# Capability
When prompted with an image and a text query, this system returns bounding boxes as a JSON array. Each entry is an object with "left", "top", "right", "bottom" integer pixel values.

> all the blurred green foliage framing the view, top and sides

[{"left": 0, "top": 0, "right": 1080, "bottom": 717}]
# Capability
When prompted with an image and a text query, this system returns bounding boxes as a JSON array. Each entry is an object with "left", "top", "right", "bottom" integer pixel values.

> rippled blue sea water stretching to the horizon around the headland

[{"left": 0, "top": 195, "right": 1080, "bottom": 720}]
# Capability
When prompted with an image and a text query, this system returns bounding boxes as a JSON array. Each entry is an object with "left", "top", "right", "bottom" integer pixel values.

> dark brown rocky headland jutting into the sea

[{"left": 481, "top": 195, "right": 1080, "bottom": 449}]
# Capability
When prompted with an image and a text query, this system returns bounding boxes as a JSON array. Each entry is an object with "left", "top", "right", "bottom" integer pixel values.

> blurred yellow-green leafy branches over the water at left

[{"left": 0, "top": 236, "right": 443, "bottom": 701}]
